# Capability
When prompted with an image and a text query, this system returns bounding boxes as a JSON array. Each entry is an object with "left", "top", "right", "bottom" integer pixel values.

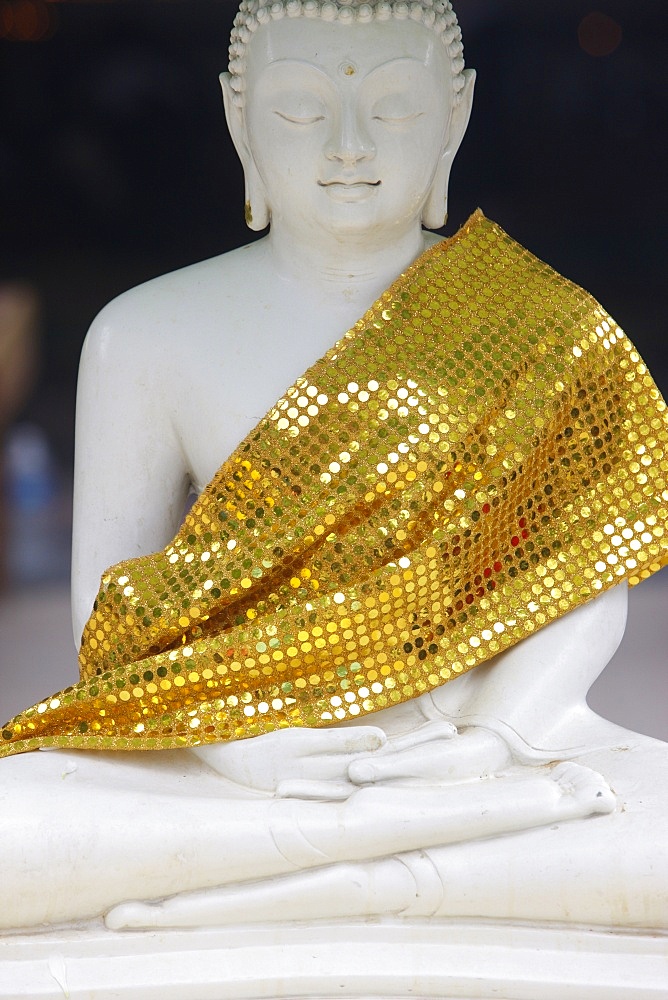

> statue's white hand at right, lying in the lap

[{"left": 348, "top": 722, "right": 512, "bottom": 785}]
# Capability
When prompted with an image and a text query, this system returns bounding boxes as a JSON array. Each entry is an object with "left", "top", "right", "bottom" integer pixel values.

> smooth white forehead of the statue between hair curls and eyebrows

[{"left": 246, "top": 17, "right": 451, "bottom": 86}]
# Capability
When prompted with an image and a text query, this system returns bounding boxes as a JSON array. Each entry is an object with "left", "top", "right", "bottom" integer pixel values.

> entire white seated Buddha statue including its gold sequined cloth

[{"left": 0, "top": 0, "right": 668, "bottom": 995}]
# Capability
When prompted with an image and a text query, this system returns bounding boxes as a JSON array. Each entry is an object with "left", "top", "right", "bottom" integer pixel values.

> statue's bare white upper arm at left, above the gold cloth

[{"left": 72, "top": 293, "right": 189, "bottom": 645}]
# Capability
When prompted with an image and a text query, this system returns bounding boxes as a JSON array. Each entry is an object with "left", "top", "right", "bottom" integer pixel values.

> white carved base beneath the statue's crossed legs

[{"left": 0, "top": 920, "right": 668, "bottom": 1000}]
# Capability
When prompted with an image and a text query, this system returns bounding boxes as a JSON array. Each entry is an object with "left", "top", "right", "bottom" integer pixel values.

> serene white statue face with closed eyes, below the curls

[{"left": 245, "top": 17, "right": 453, "bottom": 238}]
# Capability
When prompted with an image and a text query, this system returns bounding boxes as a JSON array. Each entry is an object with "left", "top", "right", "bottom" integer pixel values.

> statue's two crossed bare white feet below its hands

[{"left": 106, "top": 762, "right": 616, "bottom": 930}]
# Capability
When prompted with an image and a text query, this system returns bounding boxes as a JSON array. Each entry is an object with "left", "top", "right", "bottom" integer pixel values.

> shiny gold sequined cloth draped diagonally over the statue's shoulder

[{"left": 0, "top": 213, "right": 668, "bottom": 754}]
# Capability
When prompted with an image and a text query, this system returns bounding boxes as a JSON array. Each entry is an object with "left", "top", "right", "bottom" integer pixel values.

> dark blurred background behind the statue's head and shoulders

[{"left": 0, "top": 0, "right": 668, "bottom": 469}]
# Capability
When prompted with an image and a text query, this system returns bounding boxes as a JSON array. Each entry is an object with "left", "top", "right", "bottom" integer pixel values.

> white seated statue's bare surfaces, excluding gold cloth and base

[{"left": 0, "top": 0, "right": 668, "bottom": 996}]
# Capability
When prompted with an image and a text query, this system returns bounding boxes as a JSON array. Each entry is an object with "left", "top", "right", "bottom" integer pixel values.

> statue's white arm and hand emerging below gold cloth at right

[{"left": 326, "top": 583, "right": 627, "bottom": 794}]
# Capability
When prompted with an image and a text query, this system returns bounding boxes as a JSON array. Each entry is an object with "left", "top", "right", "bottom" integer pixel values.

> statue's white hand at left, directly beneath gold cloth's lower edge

[{"left": 192, "top": 726, "right": 387, "bottom": 799}]
